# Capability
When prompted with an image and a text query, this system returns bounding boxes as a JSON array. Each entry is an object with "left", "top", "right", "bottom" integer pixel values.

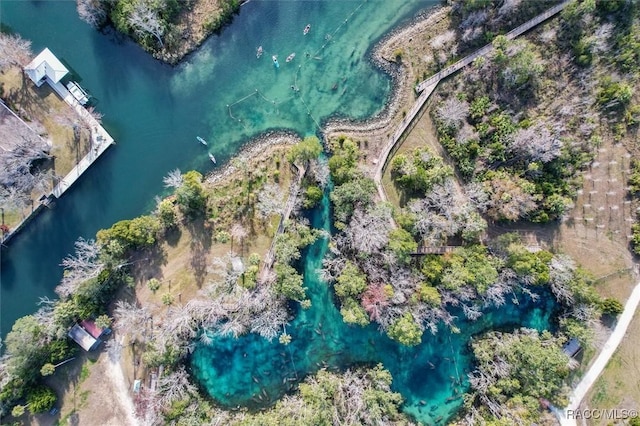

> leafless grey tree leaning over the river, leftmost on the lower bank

[{"left": 56, "top": 237, "right": 104, "bottom": 299}]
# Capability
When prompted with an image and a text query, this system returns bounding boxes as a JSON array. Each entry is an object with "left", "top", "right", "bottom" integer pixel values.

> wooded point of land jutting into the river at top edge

[{"left": 77, "top": 0, "right": 242, "bottom": 65}]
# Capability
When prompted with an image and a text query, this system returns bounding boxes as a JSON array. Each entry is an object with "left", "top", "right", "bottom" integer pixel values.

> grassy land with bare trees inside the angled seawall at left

[{"left": 0, "top": 33, "right": 101, "bottom": 242}]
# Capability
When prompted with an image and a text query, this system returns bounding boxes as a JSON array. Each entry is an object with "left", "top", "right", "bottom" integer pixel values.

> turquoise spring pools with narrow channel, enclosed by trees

[{"left": 191, "top": 191, "right": 554, "bottom": 425}]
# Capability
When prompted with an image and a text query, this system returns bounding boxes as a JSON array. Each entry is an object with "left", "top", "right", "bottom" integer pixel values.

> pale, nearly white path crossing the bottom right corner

[{"left": 560, "top": 283, "right": 640, "bottom": 426}]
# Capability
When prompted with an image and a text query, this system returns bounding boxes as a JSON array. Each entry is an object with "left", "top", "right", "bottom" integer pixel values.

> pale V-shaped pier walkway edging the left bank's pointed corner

[{"left": 47, "top": 79, "right": 115, "bottom": 198}]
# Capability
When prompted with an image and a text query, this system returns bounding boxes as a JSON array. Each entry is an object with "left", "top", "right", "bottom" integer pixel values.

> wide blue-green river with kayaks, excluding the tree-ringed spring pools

[{"left": 0, "top": 0, "right": 435, "bottom": 336}]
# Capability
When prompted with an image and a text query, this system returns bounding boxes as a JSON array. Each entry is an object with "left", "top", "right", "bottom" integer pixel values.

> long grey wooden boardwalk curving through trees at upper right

[{"left": 374, "top": 1, "right": 570, "bottom": 205}]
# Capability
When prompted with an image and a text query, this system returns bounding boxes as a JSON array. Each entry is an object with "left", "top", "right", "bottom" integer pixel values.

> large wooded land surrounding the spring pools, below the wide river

[{"left": 0, "top": 2, "right": 640, "bottom": 425}]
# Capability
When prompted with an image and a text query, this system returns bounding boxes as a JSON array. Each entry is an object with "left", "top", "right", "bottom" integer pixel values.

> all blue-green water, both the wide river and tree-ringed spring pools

[{"left": 0, "top": 0, "right": 551, "bottom": 424}]
